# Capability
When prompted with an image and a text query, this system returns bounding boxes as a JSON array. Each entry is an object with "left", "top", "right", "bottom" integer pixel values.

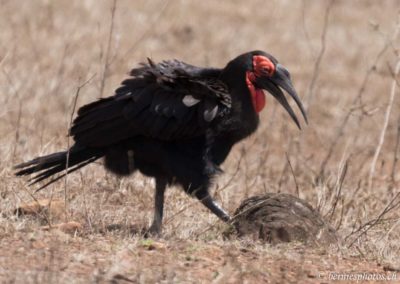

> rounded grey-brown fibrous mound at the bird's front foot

[{"left": 232, "top": 193, "right": 338, "bottom": 246}]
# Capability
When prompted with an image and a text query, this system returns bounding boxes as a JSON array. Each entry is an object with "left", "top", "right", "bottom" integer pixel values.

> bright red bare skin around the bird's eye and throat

[{"left": 246, "top": 55, "right": 275, "bottom": 113}]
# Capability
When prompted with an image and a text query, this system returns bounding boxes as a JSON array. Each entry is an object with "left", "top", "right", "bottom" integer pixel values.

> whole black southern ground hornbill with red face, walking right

[{"left": 16, "top": 51, "right": 307, "bottom": 234}]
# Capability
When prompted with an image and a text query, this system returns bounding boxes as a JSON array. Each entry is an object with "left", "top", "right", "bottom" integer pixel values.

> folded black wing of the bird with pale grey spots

[{"left": 70, "top": 57, "right": 231, "bottom": 147}]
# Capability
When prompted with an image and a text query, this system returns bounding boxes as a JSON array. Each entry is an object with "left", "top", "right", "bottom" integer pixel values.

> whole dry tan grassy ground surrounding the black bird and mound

[{"left": 0, "top": 0, "right": 400, "bottom": 283}]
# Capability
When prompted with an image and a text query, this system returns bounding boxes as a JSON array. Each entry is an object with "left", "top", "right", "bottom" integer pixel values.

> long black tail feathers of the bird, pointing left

[{"left": 14, "top": 145, "right": 104, "bottom": 190}]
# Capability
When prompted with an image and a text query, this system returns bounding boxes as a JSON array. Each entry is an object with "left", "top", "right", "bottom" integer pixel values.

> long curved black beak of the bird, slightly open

[{"left": 256, "top": 63, "right": 308, "bottom": 129}]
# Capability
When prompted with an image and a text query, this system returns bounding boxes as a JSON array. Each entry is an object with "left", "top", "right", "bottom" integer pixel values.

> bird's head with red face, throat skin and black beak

[{"left": 228, "top": 51, "right": 307, "bottom": 128}]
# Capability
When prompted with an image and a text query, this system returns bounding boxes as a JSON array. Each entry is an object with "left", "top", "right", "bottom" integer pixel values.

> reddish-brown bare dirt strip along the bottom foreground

[{"left": 0, "top": 230, "right": 395, "bottom": 283}]
